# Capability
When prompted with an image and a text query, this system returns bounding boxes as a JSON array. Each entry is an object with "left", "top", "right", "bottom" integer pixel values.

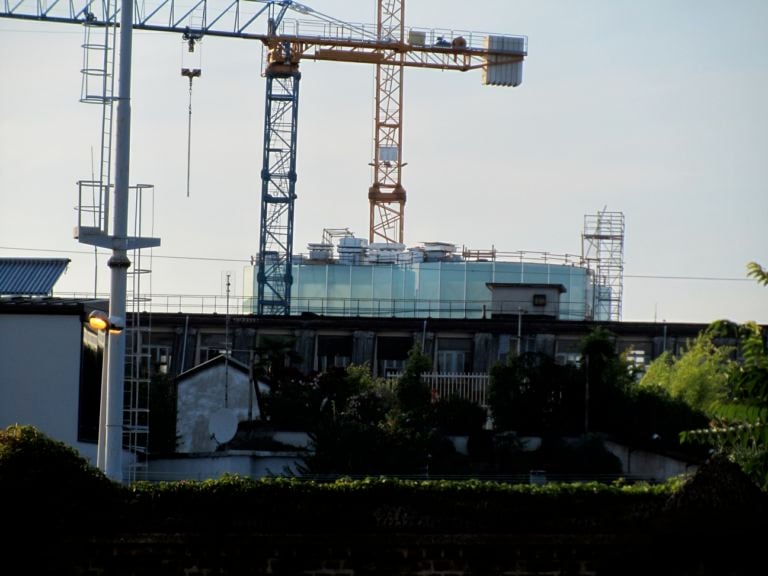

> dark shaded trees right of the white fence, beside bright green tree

[{"left": 488, "top": 328, "right": 707, "bottom": 462}]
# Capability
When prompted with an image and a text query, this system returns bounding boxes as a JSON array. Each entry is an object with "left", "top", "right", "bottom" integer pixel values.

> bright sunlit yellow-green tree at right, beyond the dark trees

[{"left": 639, "top": 324, "right": 733, "bottom": 412}]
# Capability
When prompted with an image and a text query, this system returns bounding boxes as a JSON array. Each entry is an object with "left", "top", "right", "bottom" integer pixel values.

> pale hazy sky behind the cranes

[{"left": 0, "top": 0, "right": 768, "bottom": 324}]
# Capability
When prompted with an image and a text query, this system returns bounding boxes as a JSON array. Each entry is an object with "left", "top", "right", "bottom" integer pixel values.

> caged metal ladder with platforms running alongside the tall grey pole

[{"left": 75, "top": 0, "right": 159, "bottom": 482}]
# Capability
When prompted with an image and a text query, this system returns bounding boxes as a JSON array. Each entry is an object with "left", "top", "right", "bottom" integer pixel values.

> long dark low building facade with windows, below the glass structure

[{"left": 140, "top": 313, "right": 706, "bottom": 376}]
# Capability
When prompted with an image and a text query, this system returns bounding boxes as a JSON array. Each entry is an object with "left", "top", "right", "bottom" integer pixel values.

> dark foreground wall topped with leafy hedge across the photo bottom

[{"left": 12, "top": 461, "right": 768, "bottom": 576}]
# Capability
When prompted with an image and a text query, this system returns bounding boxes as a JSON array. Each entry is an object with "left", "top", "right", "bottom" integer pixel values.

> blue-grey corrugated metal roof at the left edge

[{"left": 0, "top": 258, "right": 70, "bottom": 296}]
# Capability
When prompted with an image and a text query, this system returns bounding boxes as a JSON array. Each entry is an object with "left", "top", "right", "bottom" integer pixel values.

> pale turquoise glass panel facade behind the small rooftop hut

[{"left": 244, "top": 261, "right": 605, "bottom": 320}]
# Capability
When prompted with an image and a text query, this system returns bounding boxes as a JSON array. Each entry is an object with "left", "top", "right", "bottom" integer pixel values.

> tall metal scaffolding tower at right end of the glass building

[{"left": 581, "top": 209, "right": 624, "bottom": 321}]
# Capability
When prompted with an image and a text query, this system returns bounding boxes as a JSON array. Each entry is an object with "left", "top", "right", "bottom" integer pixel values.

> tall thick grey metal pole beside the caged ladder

[{"left": 104, "top": 0, "right": 133, "bottom": 482}]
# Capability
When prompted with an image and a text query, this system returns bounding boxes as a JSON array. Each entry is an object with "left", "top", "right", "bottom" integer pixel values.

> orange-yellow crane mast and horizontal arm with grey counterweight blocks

[{"left": 266, "top": 0, "right": 527, "bottom": 243}]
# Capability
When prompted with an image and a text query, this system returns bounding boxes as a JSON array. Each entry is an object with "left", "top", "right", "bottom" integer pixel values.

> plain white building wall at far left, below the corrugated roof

[{"left": 0, "top": 314, "right": 96, "bottom": 465}]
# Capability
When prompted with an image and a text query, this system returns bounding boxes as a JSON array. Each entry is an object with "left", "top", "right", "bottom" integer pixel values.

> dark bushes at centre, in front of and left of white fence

[{"left": 303, "top": 344, "right": 486, "bottom": 476}]
